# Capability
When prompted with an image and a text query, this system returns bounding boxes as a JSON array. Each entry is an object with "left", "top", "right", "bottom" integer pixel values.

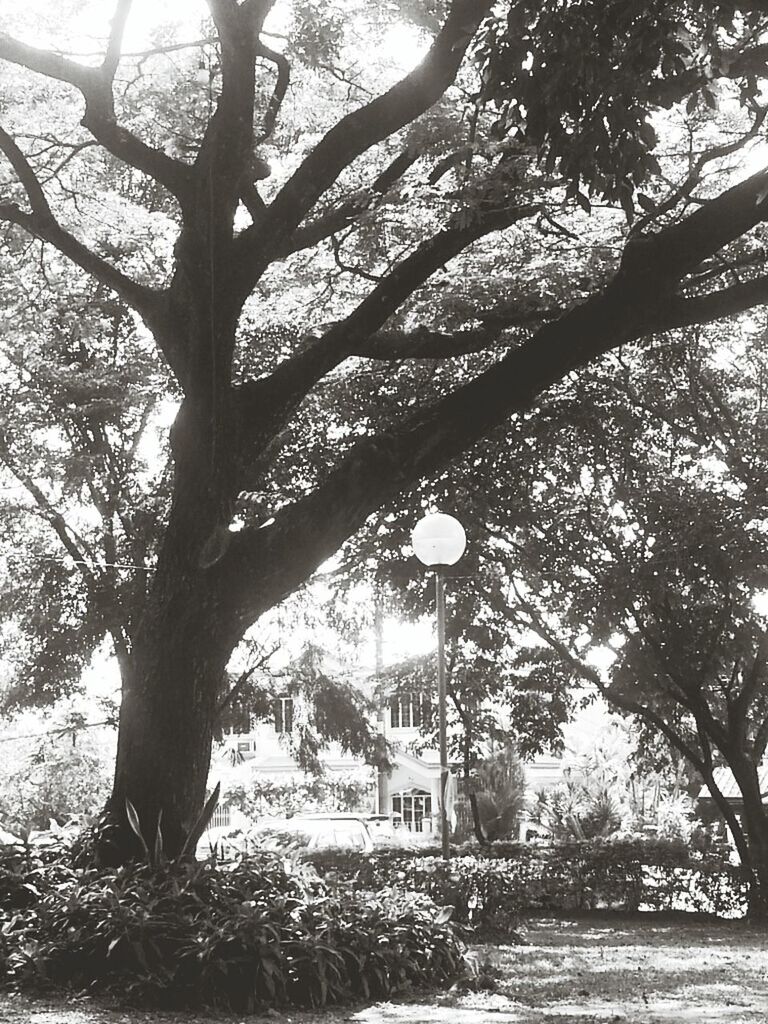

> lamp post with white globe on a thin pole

[{"left": 411, "top": 512, "right": 467, "bottom": 860}]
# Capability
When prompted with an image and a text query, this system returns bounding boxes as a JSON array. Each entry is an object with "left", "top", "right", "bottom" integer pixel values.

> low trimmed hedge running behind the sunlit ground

[{"left": 312, "top": 840, "right": 746, "bottom": 931}]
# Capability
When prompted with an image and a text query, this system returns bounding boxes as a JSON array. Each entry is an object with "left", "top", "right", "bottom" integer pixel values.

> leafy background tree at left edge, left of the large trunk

[{"left": 0, "top": 282, "right": 170, "bottom": 711}]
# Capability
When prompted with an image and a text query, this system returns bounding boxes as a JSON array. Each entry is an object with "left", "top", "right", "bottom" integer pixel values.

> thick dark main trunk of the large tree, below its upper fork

[{"left": 98, "top": 368, "right": 248, "bottom": 863}]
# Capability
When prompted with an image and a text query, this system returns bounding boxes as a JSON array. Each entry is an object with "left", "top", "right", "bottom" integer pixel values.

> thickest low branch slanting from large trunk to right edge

[{"left": 216, "top": 163, "right": 768, "bottom": 621}]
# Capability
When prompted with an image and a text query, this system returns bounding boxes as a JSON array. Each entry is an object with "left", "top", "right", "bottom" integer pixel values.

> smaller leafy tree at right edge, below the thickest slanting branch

[{"left": 475, "top": 332, "right": 768, "bottom": 913}]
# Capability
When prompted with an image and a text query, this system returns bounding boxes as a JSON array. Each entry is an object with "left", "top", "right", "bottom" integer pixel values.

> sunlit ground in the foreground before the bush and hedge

[{"left": 0, "top": 915, "right": 768, "bottom": 1024}]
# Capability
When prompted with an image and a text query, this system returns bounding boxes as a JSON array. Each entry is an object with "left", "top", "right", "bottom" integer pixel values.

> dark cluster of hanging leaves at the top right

[{"left": 476, "top": 0, "right": 765, "bottom": 202}]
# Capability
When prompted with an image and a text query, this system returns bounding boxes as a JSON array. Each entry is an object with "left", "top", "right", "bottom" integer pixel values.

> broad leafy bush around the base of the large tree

[{"left": 2, "top": 857, "right": 463, "bottom": 1013}]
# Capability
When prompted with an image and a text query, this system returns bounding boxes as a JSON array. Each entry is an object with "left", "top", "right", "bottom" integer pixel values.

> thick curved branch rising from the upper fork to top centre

[{"left": 231, "top": 0, "right": 493, "bottom": 299}]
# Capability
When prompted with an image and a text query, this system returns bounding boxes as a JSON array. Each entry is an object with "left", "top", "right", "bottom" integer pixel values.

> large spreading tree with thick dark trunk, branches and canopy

[{"left": 0, "top": 0, "right": 768, "bottom": 856}]
